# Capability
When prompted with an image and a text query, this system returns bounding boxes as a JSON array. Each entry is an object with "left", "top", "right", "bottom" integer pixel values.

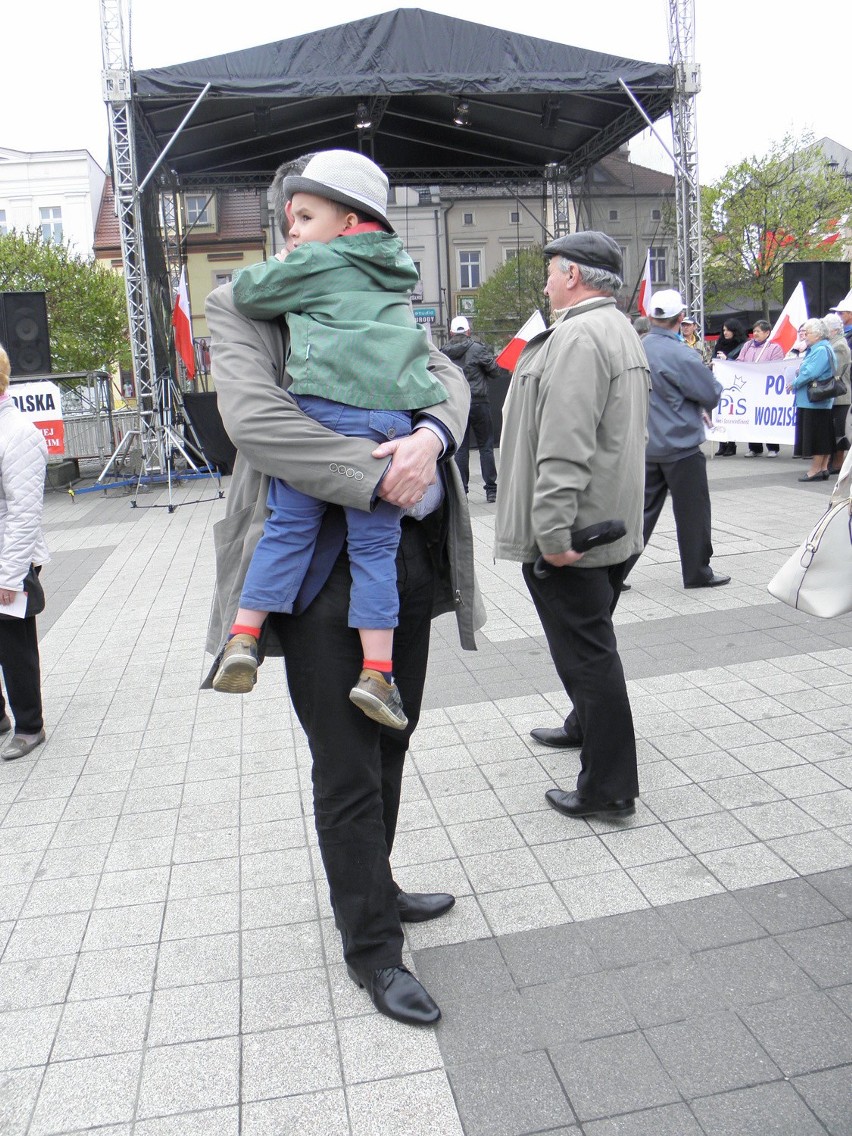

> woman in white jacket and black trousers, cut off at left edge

[{"left": 0, "top": 346, "right": 50, "bottom": 761}]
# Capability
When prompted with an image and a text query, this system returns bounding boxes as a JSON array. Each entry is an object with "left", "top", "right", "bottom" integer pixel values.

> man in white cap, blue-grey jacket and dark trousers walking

[{"left": 628, "top": 289, "right": 730, "bottom": 587}]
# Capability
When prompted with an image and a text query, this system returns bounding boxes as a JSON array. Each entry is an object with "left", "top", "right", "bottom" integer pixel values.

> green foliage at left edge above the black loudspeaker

[{"left": 0, "top": 229, "right": 131, "bottom": 371}]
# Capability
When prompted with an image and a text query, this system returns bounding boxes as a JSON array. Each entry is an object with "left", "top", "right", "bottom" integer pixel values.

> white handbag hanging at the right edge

[{"left": 767, "top": 450, "right": 852, "bottom": 618}]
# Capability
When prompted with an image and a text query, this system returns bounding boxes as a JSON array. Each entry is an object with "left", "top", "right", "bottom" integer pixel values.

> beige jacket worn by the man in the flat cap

[{"left": 494, "top": 296, "right": 651, "bottom": 568}]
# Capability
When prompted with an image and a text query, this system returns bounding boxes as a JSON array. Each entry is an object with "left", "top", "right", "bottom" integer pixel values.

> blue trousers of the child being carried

[{"left": 240, "top": 395, "right": 411, "bottom": 629}]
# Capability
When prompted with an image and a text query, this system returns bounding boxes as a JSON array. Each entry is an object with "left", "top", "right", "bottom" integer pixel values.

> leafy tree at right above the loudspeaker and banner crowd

[{"left": 702, "top": 135, "right": 851, "bottom": 317}]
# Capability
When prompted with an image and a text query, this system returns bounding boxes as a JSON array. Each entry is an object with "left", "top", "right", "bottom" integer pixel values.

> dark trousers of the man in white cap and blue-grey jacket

[{"left": 627, "top": 451, "right": 713, "bottom": 584}]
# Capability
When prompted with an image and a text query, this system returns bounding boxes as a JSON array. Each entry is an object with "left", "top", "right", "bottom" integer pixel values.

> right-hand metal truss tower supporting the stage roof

[{"left": 668, "top": 0, "right": 704, "bottom": 328}]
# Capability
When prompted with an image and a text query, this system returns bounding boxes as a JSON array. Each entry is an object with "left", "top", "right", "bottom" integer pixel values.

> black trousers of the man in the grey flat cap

[{"left": 523, "top": 562, "right": 638, "bottom": 802}]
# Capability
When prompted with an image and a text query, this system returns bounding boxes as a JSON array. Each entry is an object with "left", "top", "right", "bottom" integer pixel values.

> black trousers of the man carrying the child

[{"left": 269, "top": 519, "right": 435, "bottom": 971}]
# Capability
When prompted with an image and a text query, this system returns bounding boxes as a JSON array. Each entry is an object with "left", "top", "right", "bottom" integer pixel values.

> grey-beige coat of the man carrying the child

[{"left": 207, "top": 284, "right": 485, "bottom": 663}]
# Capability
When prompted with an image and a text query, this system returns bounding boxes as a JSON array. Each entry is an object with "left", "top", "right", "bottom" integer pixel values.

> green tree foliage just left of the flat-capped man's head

[{"left": 474, "top": 244, "right": 549, "bottom": 351}]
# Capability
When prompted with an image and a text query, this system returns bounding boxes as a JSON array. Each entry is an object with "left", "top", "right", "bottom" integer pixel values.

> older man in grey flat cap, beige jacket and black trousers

[{"left": 495, "top": 232, "right": 650, "bottom": 817}]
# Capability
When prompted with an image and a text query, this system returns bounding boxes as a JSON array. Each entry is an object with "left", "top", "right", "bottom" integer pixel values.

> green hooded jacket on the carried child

[{"left": 234, "top": 233, "right": 446, "bottom": 410}]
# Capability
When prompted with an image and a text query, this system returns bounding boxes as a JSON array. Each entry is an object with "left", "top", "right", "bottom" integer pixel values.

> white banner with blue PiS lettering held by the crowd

[{"left": 707, "top": 359, "right": 801, "bottom": 445}]
